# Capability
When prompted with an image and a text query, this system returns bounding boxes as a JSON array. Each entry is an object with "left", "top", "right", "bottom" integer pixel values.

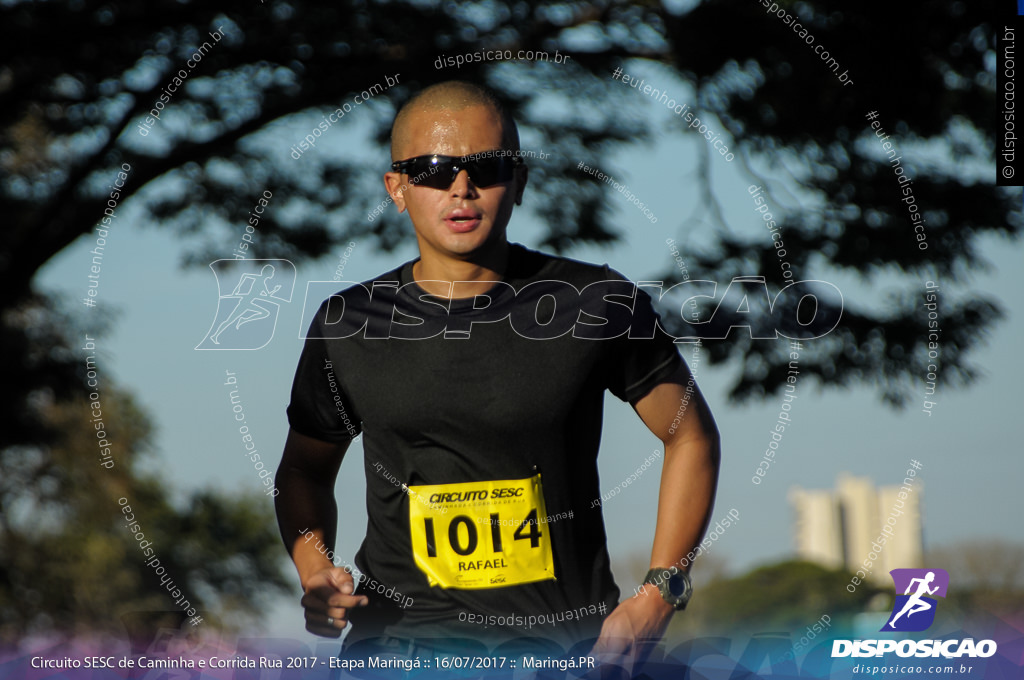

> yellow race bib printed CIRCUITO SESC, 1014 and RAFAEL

[{"left": 409, "top": 474, "right": 555, "bottom": 589}]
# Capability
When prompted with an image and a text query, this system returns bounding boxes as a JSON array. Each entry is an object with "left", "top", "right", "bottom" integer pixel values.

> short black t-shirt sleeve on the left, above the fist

[{"left": 287, "top": 313, "right": 362, "bottom": 443}]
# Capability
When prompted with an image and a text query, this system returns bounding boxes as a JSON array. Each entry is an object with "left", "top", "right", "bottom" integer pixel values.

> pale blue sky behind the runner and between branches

[{"left": 36, "top": 68, "right": 1024, "bottom": 635}]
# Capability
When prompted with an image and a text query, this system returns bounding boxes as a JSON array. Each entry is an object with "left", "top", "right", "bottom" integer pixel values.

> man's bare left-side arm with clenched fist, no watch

[{"left": 274, "top": 430, "right": 367, "bottom": 637}]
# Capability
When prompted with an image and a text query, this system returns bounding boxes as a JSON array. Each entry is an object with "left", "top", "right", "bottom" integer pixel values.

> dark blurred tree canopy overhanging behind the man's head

[{"left": 0, "top": 0, "right": 1021, "bottom": 417}]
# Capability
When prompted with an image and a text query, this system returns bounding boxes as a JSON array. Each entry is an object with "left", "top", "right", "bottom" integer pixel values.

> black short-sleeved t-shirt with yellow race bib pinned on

[{"left": 288, "top": 244, "right": 682, "bottom": 641}]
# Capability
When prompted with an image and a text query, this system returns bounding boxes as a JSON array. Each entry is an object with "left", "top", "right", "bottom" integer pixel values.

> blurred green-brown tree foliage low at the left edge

[{"left": 0, "top": 314, "right": 290, "bottom": 643}]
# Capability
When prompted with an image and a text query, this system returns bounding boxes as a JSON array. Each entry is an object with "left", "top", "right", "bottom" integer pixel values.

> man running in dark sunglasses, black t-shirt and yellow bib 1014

[{"left": 275, "top": 82, "right": 719, "bottom": 667}]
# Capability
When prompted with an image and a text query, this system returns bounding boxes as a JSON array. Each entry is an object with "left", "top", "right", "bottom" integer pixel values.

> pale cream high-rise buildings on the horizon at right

[{"left": 790, "top": 473, "right": 924, "bottom": 586}]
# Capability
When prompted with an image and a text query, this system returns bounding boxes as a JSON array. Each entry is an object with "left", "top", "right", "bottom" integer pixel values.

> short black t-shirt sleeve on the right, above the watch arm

[{"left": 605, "top": 269, "right": 683, "bottom": 405}]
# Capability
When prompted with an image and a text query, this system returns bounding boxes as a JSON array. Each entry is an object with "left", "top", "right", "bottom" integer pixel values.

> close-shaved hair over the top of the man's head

[{"left": 391, "top": 80, "right": 519, "bottom": 161}]
